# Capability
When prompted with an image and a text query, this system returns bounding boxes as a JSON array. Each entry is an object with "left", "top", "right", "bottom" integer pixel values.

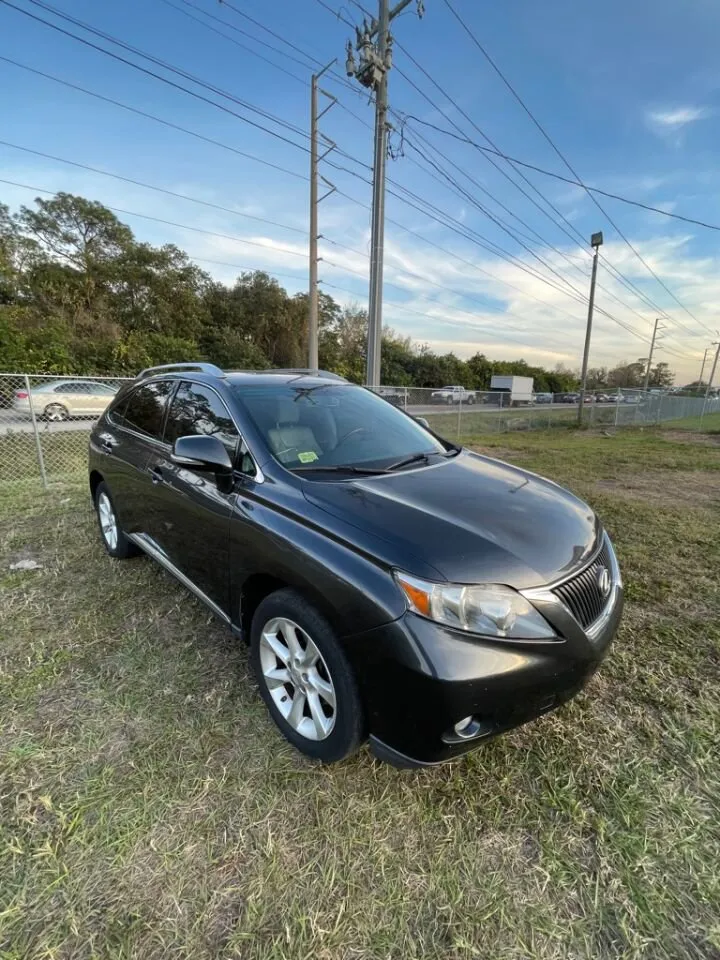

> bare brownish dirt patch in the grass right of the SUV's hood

[{"left": 593, "top": 470, "right": 720, "bottom": 507}]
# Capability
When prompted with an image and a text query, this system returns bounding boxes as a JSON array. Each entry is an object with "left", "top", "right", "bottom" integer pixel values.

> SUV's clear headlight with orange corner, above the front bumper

[{"left": 395, "top": 571, "right": 556, "bottom": 640}]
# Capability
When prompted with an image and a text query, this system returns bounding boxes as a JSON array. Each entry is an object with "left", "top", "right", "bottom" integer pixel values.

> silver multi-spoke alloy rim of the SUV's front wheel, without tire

[{"left": 259, "top": 617, "right": 337, "bottom": 740}]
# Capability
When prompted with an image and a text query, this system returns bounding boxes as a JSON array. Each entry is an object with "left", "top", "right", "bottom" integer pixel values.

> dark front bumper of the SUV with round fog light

[{"left": 346, "top": 544, "right": 623, "bottom": 766}]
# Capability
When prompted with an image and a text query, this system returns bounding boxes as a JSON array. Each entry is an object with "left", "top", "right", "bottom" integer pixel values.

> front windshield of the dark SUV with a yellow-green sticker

[{"left": 233, "top": 381, "right": 454, "bottom": 473}]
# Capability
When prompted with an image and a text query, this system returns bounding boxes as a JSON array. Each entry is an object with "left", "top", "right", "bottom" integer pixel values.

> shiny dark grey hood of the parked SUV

[{"left": 303, "top": 451, "right": 600, "bottom": 589}]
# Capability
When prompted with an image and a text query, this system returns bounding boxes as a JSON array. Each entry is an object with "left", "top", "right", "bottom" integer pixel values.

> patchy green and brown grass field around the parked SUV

[{"left": 0, "top": 430, "right": 720, "bottom": 960}]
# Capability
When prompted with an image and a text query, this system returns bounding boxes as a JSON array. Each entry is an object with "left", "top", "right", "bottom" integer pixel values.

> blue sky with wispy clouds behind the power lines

[{"left": 0, "top": 0, "right": 720, "bottom": 382}]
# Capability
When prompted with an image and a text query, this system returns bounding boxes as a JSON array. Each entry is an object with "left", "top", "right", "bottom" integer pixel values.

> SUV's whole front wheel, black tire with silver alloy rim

[{"left": 250, "top": 589, "right": 365, "bottom": 763}]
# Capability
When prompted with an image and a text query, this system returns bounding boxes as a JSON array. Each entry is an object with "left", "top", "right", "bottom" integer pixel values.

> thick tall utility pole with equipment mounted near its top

[{"left": 346, "top": 0, "right": 424, "bottom": 387}]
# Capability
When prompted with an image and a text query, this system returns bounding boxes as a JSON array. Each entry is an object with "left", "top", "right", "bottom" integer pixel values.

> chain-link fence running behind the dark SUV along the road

[{"left": 0, "top": 373, "right": 720, "bottom": 493}]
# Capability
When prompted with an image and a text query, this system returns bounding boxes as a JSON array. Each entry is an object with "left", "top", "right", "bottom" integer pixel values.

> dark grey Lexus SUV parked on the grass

[{"left": 90, "top": 364, "right": 622, "bottom": 766}]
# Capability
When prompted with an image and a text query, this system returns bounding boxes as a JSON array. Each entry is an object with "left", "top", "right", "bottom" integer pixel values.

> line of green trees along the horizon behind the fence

[{"left": 0, "top": 193, "right": 672, "bottom": 392}]
